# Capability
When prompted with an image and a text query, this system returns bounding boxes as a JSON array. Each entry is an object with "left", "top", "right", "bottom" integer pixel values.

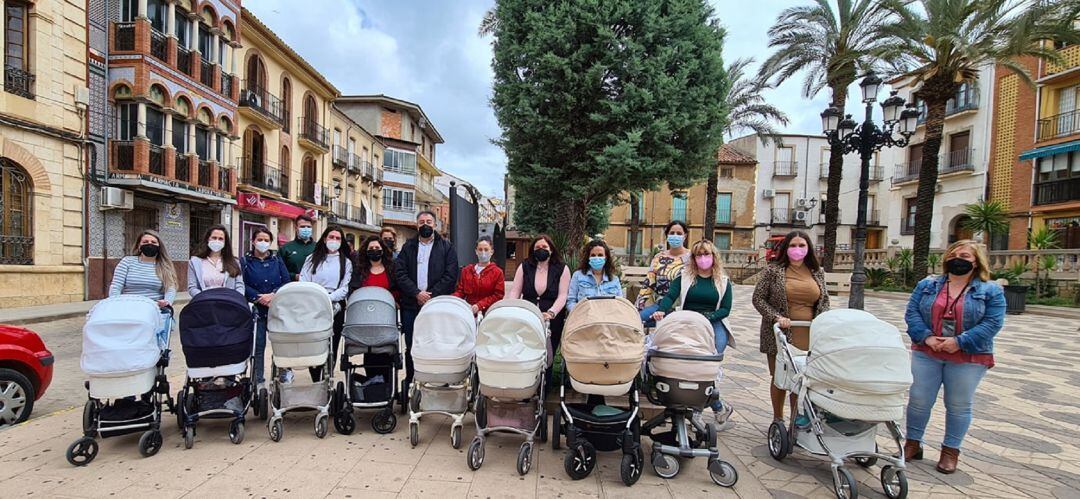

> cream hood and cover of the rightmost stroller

[{"left": 802, "top": 309, "right": 912, "bottom": 420}]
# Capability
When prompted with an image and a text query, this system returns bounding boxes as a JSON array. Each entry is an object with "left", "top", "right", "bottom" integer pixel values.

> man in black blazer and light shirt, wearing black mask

[{"left": 394, "top": 211, "right": 461, "bottom": 393}]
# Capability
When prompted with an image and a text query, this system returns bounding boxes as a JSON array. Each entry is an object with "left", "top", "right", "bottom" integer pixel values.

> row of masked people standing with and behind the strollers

[{"left": 110, "top": 212, "right": 1004, "bottom": 473}]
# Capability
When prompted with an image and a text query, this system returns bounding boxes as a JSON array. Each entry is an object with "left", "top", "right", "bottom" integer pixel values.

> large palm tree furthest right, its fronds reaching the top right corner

[{"left": 878, "top": 0, "right": 1080, "bottom": 278}]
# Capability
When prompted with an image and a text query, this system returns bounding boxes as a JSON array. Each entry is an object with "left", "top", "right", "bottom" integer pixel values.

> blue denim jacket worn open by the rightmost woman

[{"left": 904, "top": 275, "right": 1005, "bottom": 353}]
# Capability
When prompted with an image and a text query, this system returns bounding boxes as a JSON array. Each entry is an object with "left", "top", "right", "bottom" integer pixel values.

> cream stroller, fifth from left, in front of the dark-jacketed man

[{"left": 408, "top": 296, "right": 476, "bottom": 448}]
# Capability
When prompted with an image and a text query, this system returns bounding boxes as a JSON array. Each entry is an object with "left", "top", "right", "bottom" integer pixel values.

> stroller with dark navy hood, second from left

[{"left": 176, "top": 287, "right": 266, "bottom": 448}]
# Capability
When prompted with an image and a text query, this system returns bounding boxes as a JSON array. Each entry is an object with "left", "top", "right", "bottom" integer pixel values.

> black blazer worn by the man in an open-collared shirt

[{"left": 394, "top": 232, "right": 461, "bottom": 310}]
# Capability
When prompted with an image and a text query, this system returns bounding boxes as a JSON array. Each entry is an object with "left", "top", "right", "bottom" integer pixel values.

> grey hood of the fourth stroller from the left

[{"left": 341, "top": 286, "right": 397, "bottom": 347}]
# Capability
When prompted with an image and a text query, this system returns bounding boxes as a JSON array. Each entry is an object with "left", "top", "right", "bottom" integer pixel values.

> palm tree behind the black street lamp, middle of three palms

[{"left": 759, "top": 0, "right": 888, "bottom": 271}]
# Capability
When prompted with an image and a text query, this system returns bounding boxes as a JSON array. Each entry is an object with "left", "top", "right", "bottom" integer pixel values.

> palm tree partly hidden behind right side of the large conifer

[{"left": 703, "top": 58, "right": 787, "bottom": 241}]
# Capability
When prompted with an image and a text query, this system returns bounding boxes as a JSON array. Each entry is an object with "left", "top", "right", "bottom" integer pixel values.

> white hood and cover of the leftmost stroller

[{"left": 80, "top": 295, "right": 164, "bottom": 376}]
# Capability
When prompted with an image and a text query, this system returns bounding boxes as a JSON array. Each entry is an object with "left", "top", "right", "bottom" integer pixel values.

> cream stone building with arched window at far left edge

[{"left": 0, "top": 0, "right": 89, "bottom": 308}]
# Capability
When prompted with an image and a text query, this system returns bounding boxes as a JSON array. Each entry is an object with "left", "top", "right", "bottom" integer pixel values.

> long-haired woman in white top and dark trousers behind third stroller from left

[{"left": 300, "top": 226, "right": 352, "bottom": 381}]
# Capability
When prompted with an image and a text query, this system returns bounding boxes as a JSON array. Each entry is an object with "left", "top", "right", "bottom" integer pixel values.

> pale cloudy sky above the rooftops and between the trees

[{"left": 244, "top": 0, "right": 868, "bottom": 197}]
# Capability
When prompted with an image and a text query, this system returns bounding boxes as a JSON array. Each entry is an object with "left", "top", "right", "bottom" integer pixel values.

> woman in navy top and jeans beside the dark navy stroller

[{"left": 240, "top": 227, "right": 293, "bottom": 385}]
